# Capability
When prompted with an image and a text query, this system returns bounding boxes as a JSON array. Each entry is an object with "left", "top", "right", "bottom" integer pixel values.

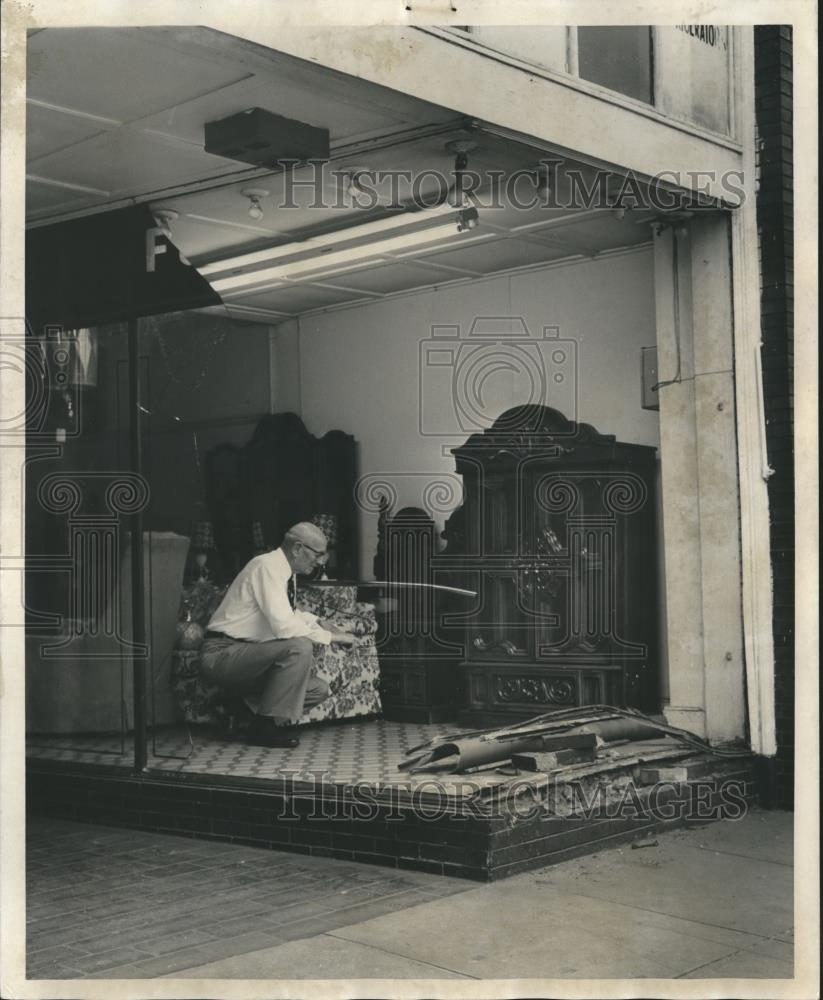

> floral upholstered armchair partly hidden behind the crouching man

[{"left": 171, "top": 580, "right": 382, "bottom": 724}]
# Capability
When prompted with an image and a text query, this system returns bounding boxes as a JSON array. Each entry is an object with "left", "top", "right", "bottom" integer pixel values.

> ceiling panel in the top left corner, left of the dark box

[{"left": 27, "top": 28, "right": 253, "bottom": 122}]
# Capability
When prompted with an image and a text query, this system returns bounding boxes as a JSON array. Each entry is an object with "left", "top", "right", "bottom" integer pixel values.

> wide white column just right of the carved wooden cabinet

[{"left": 655, "top": 213, "right": 746, "bottom": 741}]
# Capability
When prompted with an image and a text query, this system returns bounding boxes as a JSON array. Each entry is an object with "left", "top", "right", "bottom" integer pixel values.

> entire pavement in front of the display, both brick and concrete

[{"left": 28, "top": 811, "right": 793, "bottom": 980}]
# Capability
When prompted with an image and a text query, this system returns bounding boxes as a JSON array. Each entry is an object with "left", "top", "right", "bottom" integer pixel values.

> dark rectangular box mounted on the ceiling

[{"left": 205, "top": 108, "right": 329, "bottom": 167}]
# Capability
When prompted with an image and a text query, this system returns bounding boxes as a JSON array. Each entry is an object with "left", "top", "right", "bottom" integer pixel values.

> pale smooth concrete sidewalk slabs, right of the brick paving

[{"left": 169, "top": 811, "right": 793, "bottom": 979}]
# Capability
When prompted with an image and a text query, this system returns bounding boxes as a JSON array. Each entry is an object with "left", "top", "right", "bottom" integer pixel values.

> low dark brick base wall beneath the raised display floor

[{"left": 26, "top": 755, "right": 758, "bottom": 882}]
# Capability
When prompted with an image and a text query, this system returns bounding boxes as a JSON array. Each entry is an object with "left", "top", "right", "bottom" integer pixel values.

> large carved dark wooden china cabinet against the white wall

[{"left": 434, "top": 406, "right": 659, "bottom": 725}]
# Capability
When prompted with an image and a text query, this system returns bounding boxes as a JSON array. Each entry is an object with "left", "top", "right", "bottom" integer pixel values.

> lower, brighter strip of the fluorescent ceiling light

[{"left": 211, "top": 217, "right": 491, "bottom": 295}]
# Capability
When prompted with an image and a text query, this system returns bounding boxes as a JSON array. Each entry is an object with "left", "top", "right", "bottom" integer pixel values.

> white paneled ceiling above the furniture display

[{"left": 27, "top": 28, "right": 650, "bottom": 320}]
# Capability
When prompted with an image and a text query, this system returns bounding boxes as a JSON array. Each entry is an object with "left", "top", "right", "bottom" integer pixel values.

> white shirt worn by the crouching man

[{"left": 208, "top": 549, "right": 331, "bottom": 645}]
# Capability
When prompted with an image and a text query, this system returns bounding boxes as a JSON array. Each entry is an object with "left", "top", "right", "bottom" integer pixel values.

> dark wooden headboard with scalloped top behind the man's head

[{"left": 205, "top": 413, "right": 359, "bottom": 581}]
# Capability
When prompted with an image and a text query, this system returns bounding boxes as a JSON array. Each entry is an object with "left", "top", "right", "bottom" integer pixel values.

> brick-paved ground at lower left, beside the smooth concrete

[{"left": 26, "top": 817, "right": 471, "bottom": 979}]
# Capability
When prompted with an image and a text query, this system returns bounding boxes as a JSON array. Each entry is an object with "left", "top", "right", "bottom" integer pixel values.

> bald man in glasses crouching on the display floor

[{"left": 200, "top": 522, "right": 355, "bottom": 747}]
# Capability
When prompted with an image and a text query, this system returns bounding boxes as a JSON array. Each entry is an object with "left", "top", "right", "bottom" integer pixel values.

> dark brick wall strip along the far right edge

[{"left": 754, "top": 25, "right": 794, "bottom": 808}]
